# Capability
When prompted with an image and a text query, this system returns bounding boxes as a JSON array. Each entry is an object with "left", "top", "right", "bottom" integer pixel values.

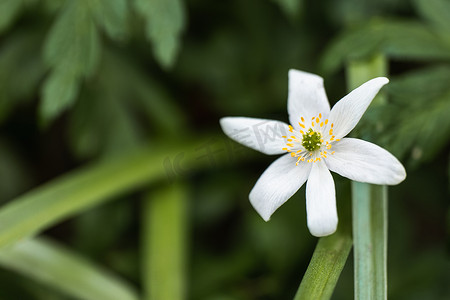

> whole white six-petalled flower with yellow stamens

[{"left": 220, "top": 70, "right": 406, "bottom": 236}]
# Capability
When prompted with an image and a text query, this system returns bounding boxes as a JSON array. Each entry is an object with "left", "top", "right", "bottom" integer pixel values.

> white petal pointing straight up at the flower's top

[{"left": 288, "top": 70, "right": 330, "bottom": 128}]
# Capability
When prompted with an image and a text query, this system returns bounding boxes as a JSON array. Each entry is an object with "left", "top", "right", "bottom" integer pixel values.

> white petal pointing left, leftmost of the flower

[{"left": 220, "top": 117, "right": 289, "bottom": 155}]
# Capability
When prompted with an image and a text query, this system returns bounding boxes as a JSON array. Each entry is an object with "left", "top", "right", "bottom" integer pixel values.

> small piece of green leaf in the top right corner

[{"left": 414, "top": 0, "right": 450, "bottom": 34}]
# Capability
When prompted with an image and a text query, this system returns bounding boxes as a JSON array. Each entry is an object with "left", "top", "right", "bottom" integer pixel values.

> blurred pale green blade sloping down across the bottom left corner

[{"left": 0, "top": 238, "right": 138, "bottom": 300}]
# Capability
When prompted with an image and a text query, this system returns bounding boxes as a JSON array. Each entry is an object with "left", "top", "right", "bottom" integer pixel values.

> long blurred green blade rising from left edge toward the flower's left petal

[{"left": 0, "top": 137, "right": 223, "bottom": 247}]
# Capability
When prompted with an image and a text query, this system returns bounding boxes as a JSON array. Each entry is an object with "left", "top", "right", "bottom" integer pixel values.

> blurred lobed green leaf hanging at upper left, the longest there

[{"left": 39, "top": 0, "right": 100, "bottom": 123}]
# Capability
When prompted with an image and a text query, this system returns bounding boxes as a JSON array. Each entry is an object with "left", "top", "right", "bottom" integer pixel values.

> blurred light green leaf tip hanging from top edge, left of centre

[{"left": 134, "top": 0, "right": 185, "bottom": 69}]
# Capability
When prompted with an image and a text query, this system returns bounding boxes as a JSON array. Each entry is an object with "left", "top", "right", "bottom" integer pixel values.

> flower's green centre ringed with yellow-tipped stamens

[{"left": 283, "top": 114, "right": 339, "bottom": 165}]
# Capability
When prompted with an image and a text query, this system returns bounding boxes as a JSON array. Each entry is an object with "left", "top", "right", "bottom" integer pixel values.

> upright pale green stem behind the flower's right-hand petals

[{"left": 347, "top": 55, "right": 388, "bottom": 299}]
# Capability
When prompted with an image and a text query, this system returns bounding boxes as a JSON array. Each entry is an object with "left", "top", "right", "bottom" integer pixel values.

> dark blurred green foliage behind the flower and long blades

[{"left": 0, "top": 0, "right": 450, "bottom": 300}]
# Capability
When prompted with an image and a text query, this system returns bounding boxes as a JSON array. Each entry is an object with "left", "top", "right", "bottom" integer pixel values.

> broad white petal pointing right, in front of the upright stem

[{"left": 325, "top": 138, "right": 406, "bottom": 185}]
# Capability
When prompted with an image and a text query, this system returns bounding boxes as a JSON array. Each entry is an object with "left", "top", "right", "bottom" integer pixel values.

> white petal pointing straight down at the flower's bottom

[{"left": 306, "top": 161, "right": 338, "bottom": 236}]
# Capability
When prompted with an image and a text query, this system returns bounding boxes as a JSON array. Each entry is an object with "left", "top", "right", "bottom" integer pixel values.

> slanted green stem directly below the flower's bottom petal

[{"left": 294, "top": 229, "right": 352, "bottom": 300}]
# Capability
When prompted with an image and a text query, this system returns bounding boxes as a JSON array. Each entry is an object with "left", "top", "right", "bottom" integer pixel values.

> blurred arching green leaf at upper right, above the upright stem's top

[{"left": 321, "top": 19, "right": 450, "bottom": 73}]
